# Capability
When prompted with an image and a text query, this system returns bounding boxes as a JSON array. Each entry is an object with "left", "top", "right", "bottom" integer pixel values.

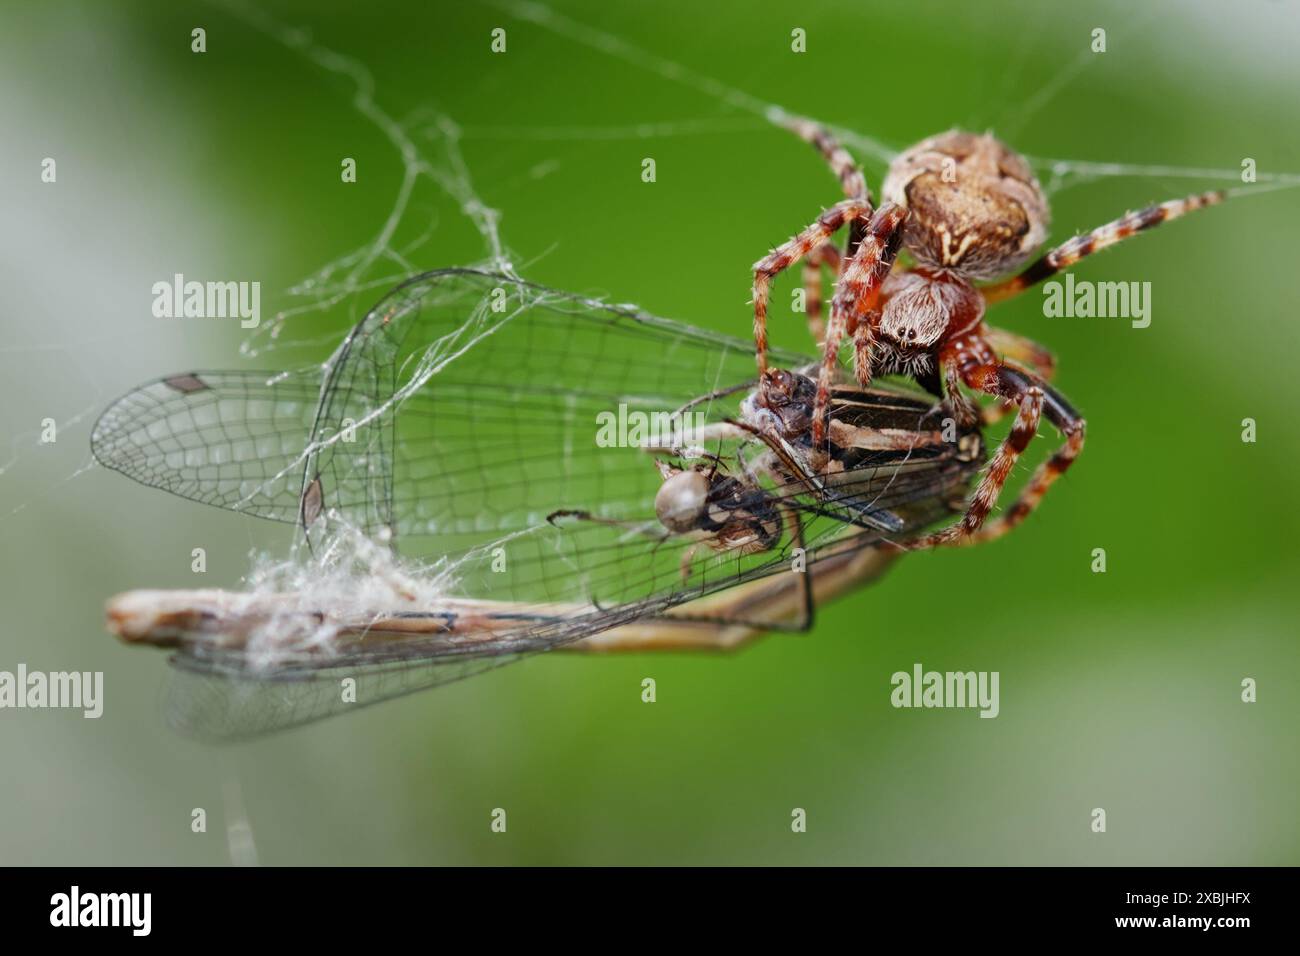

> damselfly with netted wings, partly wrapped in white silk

[{"left": 91, "top": 269, "right": 984, "bottom": 737}]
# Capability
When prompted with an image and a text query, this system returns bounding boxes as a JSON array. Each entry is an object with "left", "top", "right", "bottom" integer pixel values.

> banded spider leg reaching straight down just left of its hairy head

[{"left": 813, "top": 206, "right": 907, "bottom": 449}]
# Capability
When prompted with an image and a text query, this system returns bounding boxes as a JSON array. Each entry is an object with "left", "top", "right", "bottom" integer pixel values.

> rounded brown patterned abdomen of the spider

[{"left": 883, "top": 130, "right": 1050, "bottom": 280}]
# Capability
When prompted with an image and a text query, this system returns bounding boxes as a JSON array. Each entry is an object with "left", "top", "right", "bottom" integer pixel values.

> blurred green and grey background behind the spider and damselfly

[{"left": 0, "top": 0, "right": 1300, "bottom": 864}]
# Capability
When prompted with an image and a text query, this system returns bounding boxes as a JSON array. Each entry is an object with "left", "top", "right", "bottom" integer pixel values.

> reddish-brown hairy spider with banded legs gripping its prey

[{"left": 754, "top": 118, "right": 1225, "bottom": 548}]
